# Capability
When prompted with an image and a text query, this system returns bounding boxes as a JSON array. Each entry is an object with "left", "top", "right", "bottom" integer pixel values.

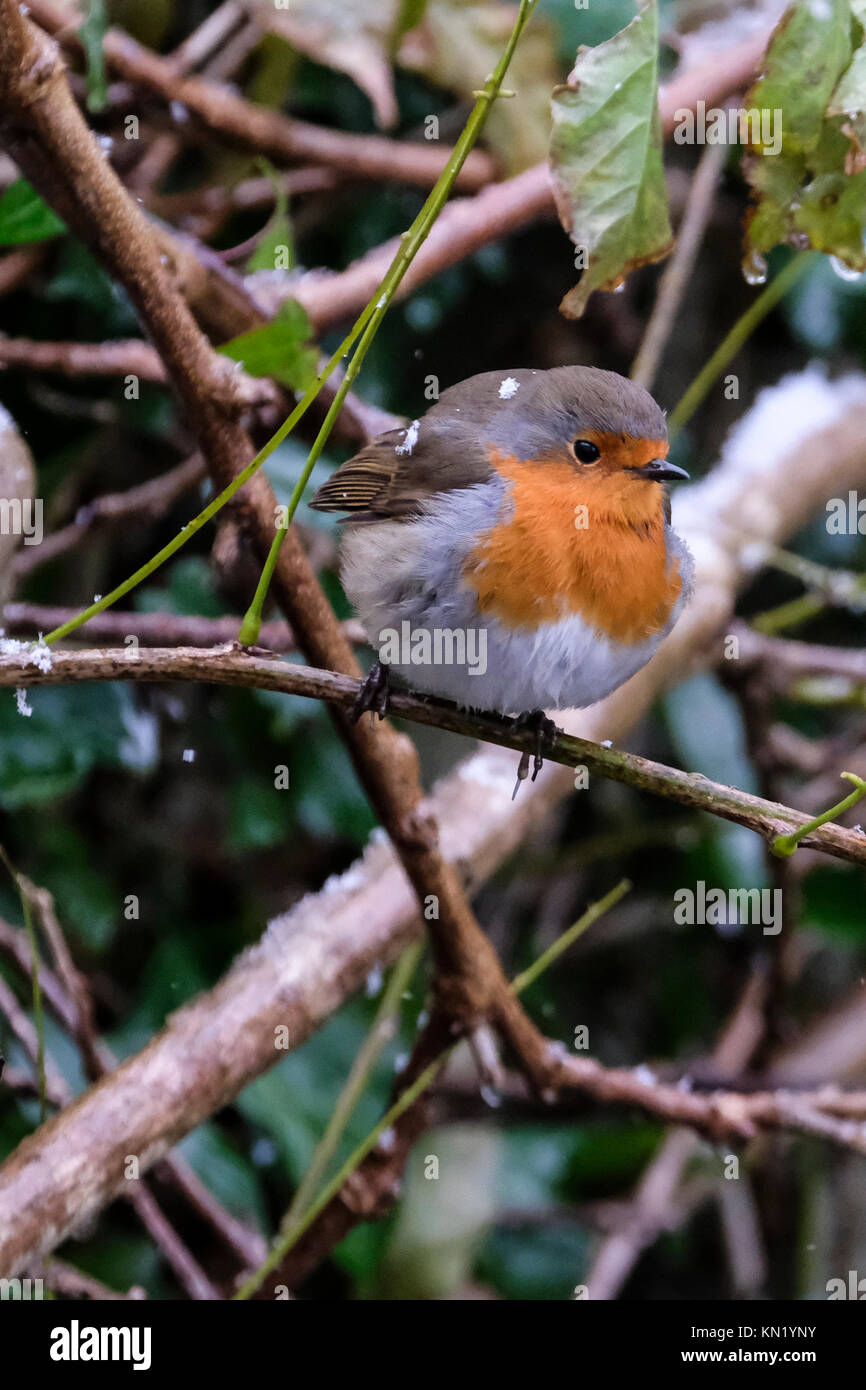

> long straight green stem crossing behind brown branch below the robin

[{"left": 235, "top": 880, "right": 630, "bottom": 1300}]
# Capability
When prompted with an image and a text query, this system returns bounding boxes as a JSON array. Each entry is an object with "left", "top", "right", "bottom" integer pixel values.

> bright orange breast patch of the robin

[{"left": 464, "top": 455, "right": 683, "bottom": 645}]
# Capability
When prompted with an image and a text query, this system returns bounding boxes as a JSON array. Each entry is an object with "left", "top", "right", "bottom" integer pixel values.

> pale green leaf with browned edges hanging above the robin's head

[{"left": 550, "top": 0, "right": 671, "bottom": 318}]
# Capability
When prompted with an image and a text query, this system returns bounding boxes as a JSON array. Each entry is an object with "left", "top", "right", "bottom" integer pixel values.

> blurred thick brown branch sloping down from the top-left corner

[{"left": 31, "top": 0, "right": 495, "bottom": 189}]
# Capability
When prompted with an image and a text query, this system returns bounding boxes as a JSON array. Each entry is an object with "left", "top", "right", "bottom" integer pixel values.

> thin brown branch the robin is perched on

[{"left": 6, "top": 644, "right": 866, "bottom": 863}]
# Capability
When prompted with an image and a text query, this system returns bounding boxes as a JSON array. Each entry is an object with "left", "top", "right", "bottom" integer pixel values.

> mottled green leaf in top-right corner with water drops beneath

[{"left": 742, "top": 0, "right": 866, "bottom": 271}]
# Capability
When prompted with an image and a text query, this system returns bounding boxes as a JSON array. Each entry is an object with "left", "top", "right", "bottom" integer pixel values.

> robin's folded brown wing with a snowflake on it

[{"left": 310, "top": 420, "right": 492, "bottom": 521}]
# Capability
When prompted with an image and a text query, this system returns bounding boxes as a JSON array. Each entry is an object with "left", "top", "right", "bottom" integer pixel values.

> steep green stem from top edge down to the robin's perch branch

[{"left": 238, "top": 0, "right": 535, "bottom": 646}]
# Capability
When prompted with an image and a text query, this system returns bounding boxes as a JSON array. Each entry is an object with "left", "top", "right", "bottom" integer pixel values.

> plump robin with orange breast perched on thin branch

[{"left": 311, "top": 367, "right": 692, "bottom": 774}]
